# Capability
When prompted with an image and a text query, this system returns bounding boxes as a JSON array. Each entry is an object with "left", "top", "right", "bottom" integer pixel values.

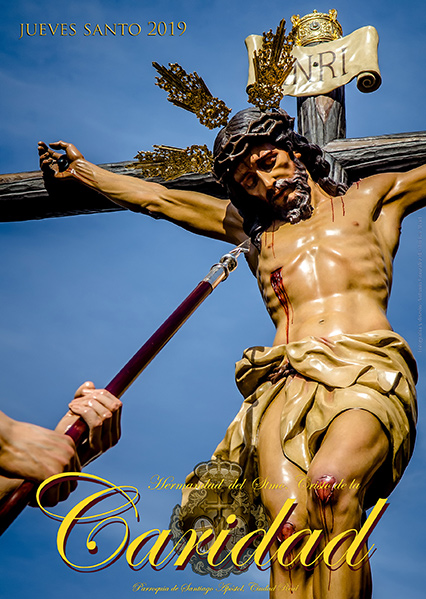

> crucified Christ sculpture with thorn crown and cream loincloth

[{"left": 39, "top": 108, "right": 426, "bottom": 599}]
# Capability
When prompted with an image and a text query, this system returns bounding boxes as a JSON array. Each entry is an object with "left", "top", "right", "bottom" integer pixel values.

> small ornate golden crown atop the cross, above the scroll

[{"left": 291, "top": 8, "right": 343, "bottom": 46}]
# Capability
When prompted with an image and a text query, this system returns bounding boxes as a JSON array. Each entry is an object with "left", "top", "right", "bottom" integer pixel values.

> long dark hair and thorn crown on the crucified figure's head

[{"left": 213, "top": 107, "right": 347, "bottom": 240}]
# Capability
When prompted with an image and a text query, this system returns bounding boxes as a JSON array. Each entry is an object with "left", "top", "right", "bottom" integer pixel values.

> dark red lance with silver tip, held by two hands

[{"left": 0, "top": 239, "right": 250, "bottom": 535}]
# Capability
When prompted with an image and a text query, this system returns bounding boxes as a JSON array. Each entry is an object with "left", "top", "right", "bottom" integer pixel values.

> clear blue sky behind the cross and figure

[{"left": 0, "top": 0, "right": 426, "bottom": 599}]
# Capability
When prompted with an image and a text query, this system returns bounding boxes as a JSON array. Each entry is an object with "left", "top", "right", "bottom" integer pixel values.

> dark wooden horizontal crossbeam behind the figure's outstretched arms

[{"left": 0, "top": 131, "right": 426, "bottom": 222}]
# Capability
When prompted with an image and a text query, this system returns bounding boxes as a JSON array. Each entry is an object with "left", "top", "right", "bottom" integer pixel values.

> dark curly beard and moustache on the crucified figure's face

[{"left": 268, "top": 158, "right": 313, "bottom": 224}]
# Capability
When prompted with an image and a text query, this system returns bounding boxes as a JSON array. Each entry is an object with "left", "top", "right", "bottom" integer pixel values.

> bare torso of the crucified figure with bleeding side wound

[{"left": 250, "top": 180, "right": 399, "bottom": 345}]
